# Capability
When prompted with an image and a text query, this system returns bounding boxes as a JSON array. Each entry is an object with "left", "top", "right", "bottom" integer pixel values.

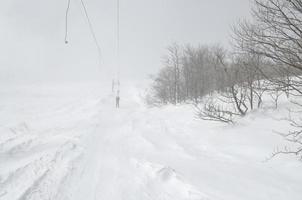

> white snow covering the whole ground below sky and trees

[{"left": 0, "top": 83, "right": 302, "bottom": 200}]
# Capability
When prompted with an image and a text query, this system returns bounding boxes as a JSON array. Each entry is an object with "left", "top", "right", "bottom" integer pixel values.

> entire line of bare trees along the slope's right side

[{"left": 148, "top": 0, "right": 302, "bottom": 158}]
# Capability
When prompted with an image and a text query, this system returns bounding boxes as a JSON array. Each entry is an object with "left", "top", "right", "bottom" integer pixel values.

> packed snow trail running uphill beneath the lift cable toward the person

[{"left": 62, "top": 92, "right": 205, "bottom": 200}]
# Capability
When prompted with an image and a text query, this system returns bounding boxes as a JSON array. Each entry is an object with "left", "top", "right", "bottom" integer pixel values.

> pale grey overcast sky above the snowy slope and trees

[{"left": 0, "top": 0, "right": 251, "bottom": 81}]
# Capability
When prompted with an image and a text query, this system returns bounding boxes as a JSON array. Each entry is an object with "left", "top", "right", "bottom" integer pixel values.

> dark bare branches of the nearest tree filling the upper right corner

[{"left": 233, "top": 0, "right": 302, "bottom": 95}]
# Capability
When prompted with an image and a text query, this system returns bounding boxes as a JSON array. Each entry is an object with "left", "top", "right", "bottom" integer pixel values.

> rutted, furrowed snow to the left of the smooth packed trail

[{"left": 0, "top": 94, "right": 96, "bottom": 200}]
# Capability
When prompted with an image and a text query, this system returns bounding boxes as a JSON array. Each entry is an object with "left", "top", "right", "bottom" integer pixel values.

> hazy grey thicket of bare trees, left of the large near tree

[{"left": 152, "top": 44, "right": 277, "bottom": 110}]
